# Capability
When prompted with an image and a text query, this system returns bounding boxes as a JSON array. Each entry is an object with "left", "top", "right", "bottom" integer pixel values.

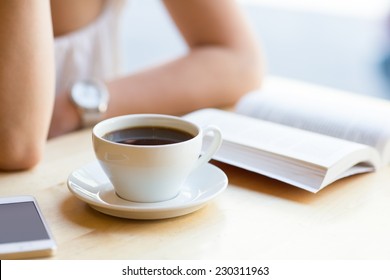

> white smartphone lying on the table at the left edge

[{"left": 0, "top": 196, "right": 56, "bottom": 259}]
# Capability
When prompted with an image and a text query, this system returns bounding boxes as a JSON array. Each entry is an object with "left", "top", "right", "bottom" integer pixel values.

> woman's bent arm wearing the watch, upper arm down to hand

[{"left": 51, "top": 0, "right": 262, "bottom": 136}]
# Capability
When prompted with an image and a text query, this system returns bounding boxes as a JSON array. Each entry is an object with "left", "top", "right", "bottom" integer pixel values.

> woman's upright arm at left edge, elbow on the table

[{"left": 0, "top": 0, "right": 55, "bottom": 170}]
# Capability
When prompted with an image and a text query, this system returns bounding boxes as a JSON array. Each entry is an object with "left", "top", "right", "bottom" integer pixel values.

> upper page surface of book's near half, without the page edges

[{"left": 185, "top": 109, "right": 378, "bottom": 170}]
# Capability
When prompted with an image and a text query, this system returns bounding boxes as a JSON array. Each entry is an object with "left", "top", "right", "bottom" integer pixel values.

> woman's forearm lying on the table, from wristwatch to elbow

[{"left": 107, "top": 46, "right": 262, "bottom": 117}]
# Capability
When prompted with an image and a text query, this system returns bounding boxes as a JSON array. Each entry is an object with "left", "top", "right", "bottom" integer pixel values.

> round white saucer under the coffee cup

[{"left": 68, "top": 161, "right": 228, "bottom": 220}]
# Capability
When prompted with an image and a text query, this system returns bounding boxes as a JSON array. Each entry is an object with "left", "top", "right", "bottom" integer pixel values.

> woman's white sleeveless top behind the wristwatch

[{"left": 54, "top": 0, "right": 122, "bottom": 94}]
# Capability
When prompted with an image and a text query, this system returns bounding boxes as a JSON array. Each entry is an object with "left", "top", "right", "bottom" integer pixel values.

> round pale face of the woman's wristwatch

[{"left": 72, "top": 82, "right": 102, "bottom": 109}]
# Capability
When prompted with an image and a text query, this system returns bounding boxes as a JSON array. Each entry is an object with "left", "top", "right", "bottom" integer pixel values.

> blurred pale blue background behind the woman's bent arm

[{"left": 122, "top": 0, "right": 390, "bottom": 99}]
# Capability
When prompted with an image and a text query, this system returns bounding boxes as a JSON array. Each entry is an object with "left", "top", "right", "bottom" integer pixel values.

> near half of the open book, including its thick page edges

[{"left": 184, "top": 109, "right": 380, "bottom": 192}]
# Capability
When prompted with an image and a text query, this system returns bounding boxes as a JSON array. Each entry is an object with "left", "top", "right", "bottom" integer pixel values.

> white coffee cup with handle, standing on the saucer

[{"left": 92, "top": 114, "right": 222, "bottom": 202}]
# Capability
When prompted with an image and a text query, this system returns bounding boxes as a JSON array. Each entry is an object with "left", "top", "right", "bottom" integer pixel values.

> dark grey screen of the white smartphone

[{"left": 0, "top": 201, "right": 50, "bottom": 244}]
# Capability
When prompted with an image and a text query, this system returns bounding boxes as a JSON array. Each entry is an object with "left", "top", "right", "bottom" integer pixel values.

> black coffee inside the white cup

[{"left": 103, "top": 126, "right": 194, "bottom": 146}]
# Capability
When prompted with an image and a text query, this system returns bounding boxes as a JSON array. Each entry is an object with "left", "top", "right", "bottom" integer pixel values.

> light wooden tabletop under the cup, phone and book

[{"left": 0, "top": 77, "right": 390, "bottom": 260}]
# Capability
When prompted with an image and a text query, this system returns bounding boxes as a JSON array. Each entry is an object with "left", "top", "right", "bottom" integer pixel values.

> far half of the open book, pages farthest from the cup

[{"left": 236, "top": 83, "right": 390, "bottom": 163}]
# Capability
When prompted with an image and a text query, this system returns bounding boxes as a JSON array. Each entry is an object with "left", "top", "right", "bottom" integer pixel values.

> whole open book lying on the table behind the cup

[{"left": 185, "top": 80, "right": 390, "bottom": 193}]
